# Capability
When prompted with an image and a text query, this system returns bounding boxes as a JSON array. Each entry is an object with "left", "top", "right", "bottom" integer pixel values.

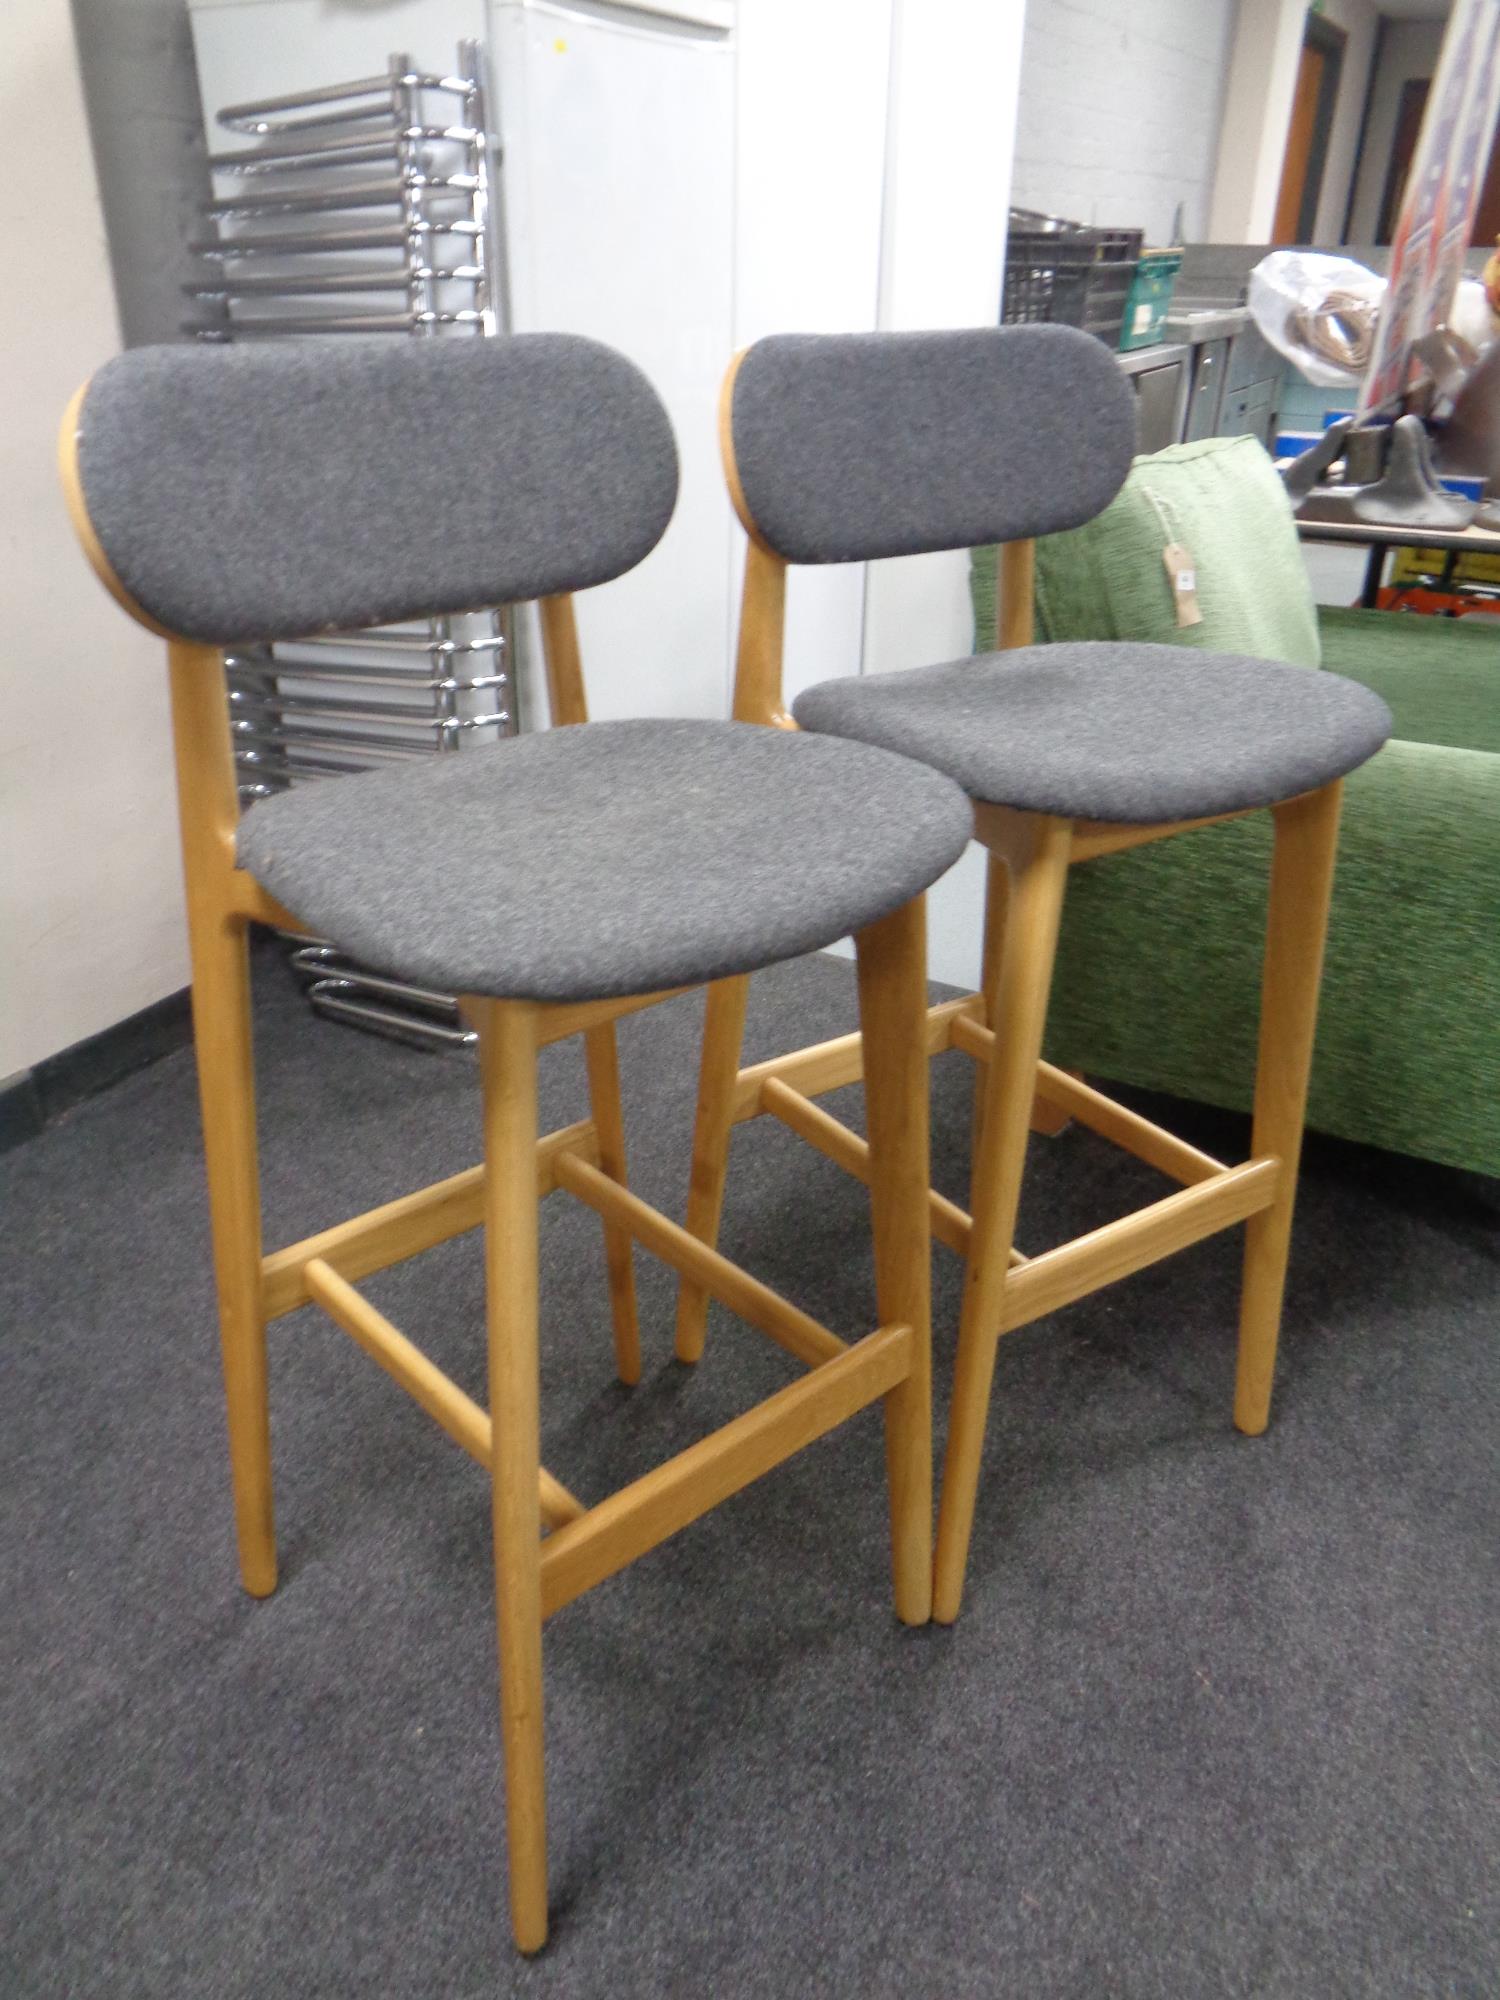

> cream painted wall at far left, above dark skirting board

[{"left": 0, "top": 0, "right": 188, "bottom": 1078}]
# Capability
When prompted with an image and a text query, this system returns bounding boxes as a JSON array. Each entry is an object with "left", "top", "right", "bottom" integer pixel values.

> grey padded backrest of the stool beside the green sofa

[{"left": 730, "top": 326, "right": 1136, "bottom": 562}]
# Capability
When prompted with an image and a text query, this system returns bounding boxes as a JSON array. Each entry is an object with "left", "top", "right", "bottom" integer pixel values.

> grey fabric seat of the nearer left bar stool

[{"left": 238, "top": 720, "right": 972, "bottom": 1000}]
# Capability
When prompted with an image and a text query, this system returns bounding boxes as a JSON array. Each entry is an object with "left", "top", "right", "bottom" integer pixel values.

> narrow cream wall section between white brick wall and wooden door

[{"left": 1208, "top": 0, "right": 1308, "bottom": 244}]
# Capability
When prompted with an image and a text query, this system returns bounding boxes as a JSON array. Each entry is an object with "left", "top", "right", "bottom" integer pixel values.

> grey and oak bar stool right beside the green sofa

[{"left": 678, "top": 326, "right": 1390, "bottom": 1620}]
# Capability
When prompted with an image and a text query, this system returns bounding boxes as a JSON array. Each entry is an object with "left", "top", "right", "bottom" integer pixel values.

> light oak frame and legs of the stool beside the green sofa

[{"left": 692, "top": 356, "right": 1342, "bottom": 1622}]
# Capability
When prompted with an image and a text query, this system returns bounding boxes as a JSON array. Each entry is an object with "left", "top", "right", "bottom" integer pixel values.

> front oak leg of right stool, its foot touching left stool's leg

[{"left": 932, "top": 814, "right": 1072, "bottom": 1624}]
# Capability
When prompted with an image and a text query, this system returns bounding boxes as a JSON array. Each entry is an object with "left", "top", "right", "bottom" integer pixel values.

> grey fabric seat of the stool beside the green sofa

[{"left": 794, "top": 642, "right": 1390, "bottom": 822}]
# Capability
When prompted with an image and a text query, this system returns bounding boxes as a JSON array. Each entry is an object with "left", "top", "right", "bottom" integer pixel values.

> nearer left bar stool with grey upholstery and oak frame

[{"left": 62, "top": 334, "right": 968, "bottom": 1952}]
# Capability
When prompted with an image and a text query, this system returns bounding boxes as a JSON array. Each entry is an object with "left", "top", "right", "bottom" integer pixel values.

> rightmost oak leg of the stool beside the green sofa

[{"left": 1234, "top": 784, "right": 1342, "bottom": 1438}]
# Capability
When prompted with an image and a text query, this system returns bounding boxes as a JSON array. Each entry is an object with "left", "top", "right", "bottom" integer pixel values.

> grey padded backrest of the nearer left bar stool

[{"left": 78, "top": 334, "right": 678, "bottom": 644}]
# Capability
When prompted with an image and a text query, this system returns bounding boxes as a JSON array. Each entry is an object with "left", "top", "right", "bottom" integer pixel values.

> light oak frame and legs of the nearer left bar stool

[{"left": 60, "top": 390, "right": 932, "bottom": 1952}]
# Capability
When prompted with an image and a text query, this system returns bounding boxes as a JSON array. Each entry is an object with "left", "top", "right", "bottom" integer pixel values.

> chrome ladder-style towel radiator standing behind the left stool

[{"left": 184, "top": 42, "right": 518, "bottom": 1046}]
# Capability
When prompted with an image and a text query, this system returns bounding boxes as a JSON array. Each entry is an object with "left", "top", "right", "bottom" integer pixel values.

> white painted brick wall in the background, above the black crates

[{"left": 1010, "top": 0, "right": 1236, "bottom": 244}]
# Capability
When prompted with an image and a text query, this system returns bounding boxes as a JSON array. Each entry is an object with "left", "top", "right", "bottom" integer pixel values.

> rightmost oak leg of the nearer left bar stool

[{"left": 854, "top": 896, "right": 932, "bottom": 1624}]
